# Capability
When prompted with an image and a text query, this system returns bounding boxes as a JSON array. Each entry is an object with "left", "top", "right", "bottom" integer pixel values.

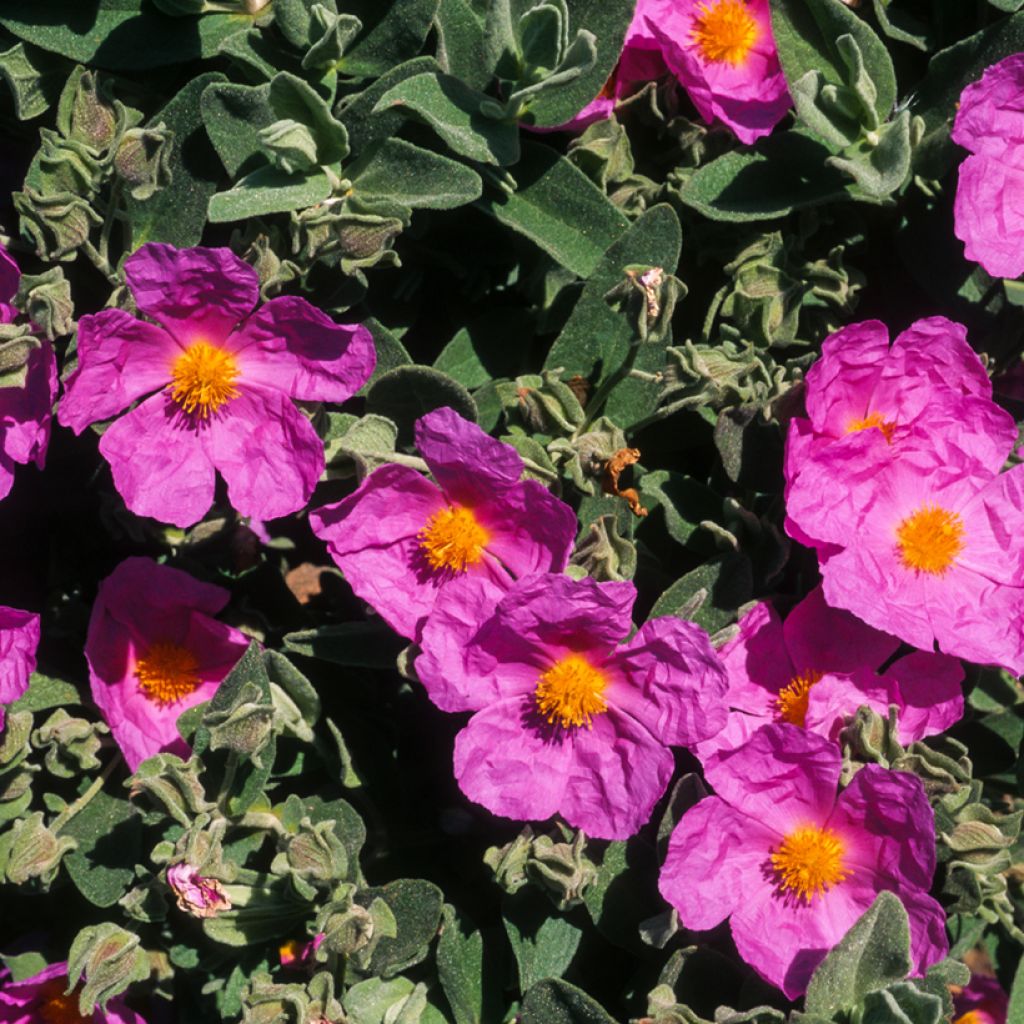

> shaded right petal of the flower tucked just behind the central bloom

[{"left": 473, "top": 480, "right": 578, "bottom": 577}]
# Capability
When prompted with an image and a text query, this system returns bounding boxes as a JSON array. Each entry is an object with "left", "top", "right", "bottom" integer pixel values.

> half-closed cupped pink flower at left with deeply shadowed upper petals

[{"left": 85, "top": 558, "right": 248, "bottom": 771}]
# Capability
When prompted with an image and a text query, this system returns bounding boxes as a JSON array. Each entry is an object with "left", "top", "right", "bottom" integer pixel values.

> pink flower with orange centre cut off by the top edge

[{"left": 640, "top": 0, "right": 792, "bottom": 144}]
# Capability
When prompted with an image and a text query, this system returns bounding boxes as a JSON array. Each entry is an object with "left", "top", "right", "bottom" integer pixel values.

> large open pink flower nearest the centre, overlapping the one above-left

[{"left": 416, "top": 574, "right": 725, "bottom": 839}]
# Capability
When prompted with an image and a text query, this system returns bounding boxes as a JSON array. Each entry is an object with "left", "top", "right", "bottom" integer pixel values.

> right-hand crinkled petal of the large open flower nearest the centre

[{"left": 603, "top": 616, "right": 728, "bottom": 745}]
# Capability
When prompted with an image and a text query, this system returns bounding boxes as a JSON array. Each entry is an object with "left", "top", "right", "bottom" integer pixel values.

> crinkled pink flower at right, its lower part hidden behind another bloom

[{"left": 785, "top": 316, "right": 1017, "bottom": 548}]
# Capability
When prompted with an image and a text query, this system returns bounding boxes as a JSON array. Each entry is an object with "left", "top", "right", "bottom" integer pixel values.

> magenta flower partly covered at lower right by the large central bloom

[{"left": 309, "top": 409, "right": 577, "bottom": 639}]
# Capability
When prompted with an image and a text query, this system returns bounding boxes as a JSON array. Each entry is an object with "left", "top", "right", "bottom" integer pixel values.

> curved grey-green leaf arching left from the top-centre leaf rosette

[{"left": 374, "top": 72, "right": 519, "bottom": 166}]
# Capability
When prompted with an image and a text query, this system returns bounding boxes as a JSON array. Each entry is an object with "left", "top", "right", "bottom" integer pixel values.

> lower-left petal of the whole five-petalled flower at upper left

[{"left": 99, "top": 393, "right": 215, "bottom": 527}]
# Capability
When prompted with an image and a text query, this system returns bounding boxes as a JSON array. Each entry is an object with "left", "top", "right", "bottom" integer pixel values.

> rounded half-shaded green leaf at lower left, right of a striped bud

[{"left": 61, "top": 791, "right": 142, "bottom": 906}]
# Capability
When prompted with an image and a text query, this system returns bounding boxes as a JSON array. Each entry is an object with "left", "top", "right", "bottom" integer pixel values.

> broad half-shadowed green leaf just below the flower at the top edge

[{"left": 679, "top": 131, "right": 849, "bottom": 221}]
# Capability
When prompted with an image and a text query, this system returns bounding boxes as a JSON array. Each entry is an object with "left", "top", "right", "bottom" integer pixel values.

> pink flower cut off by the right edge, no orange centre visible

[{"left": 952, "top": 53, "right": 1024, "bottom": 278}]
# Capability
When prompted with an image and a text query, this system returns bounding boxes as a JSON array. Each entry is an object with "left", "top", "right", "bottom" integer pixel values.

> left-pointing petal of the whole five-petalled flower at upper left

[{"left": 57, "top": 309, "right": 183, "bottom": 434}]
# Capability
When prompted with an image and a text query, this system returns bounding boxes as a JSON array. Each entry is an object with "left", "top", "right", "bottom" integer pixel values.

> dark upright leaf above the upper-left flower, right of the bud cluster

[{"left": 125, "top": 72, "right": 224, "bottom": 250}]
